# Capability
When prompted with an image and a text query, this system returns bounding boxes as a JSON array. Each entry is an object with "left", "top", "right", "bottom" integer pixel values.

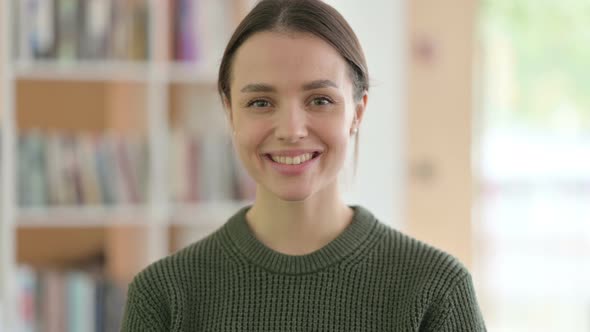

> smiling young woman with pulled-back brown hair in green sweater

[{"left": 122, "top": 0, "right": 485, "bottom": 332}]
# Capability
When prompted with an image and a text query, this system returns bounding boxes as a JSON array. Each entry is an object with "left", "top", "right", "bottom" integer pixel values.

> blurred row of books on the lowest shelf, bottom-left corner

[{"left": 16, "top": 266, "right": 126, "bottom": 332}]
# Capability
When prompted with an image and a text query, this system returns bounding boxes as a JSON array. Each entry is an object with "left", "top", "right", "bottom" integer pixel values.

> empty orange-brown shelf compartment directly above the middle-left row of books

[{"left": 15, "top": 80, "right": 147, "bottom": 134}]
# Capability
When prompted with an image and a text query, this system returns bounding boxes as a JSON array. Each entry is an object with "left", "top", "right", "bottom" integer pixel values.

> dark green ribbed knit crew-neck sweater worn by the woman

[{"left": 122, "top": 206, "right": 485, "bottom": 332}]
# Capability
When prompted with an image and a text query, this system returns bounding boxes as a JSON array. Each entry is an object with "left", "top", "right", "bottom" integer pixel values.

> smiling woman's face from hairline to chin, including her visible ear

[{"left": 227, "top": 32, "right": 366, "bottom": 201}]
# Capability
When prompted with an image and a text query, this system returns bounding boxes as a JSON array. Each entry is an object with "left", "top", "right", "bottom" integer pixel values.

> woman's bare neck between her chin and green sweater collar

[{"left": 246, "top": 184, "right": 353, "bottom": 255}]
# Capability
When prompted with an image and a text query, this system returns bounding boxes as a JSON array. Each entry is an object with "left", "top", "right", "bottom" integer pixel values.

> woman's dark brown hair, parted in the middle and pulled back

[{"left": 217, "top": 0, "right": 369, "bottom": 102}]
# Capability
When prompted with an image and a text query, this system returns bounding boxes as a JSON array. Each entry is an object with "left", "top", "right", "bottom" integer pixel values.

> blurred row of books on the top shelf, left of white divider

[{"left": 14, "top": 0, "right": 149, "bottom": 62}]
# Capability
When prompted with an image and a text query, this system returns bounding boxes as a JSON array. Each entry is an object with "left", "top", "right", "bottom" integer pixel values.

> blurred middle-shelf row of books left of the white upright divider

[{"left": 16, "top": 130, "right": 149, "bottom": 207}]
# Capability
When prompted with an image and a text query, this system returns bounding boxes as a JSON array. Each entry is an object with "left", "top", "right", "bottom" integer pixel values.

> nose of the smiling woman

[{"left": 275, "top": 105, "right": 308, "bottom": 142}]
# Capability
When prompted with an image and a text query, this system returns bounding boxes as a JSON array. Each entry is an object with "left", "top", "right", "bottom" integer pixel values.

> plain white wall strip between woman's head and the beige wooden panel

[{"left": 325, "top": 0, "right": 406, "bottom": 227}]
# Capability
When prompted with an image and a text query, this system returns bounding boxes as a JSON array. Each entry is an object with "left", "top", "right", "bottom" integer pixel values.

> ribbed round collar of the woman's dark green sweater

[{"left": 222, "top": 206, "right": 378, "bottom": 274}]
